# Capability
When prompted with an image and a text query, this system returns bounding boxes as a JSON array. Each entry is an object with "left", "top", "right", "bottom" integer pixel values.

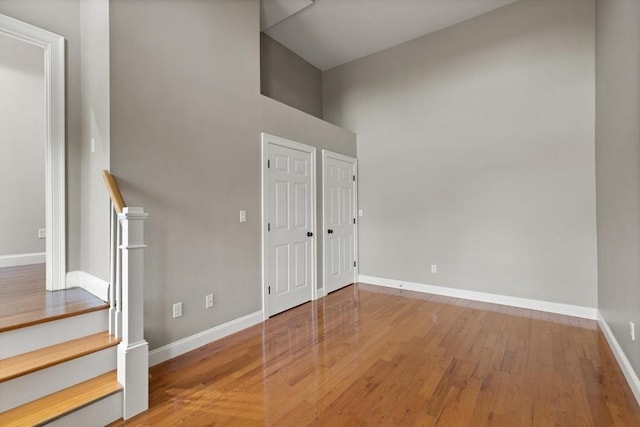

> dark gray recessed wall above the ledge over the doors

[{"left": 260, "top": 33, "right": 322, "bottom": 118}]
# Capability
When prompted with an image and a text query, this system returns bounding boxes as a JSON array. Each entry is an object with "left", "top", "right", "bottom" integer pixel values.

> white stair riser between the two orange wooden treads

[{"left": 0, "top": 347, "right": 116, "bottom": 412}]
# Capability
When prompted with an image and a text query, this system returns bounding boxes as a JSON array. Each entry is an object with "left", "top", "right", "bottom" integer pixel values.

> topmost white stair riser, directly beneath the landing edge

[{"left": 0, "top": 310, "right": 109, "bottom": 359}]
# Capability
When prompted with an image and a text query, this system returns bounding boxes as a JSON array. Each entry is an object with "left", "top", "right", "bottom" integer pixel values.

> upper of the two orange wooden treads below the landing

[{"left": 0, "top": 331, "right": 121, "bottom": 382}]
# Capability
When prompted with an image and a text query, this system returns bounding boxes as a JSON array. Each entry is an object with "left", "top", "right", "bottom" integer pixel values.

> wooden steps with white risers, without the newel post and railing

[{"left": 0, "top": 300, "right": 122, "bottom": 426}]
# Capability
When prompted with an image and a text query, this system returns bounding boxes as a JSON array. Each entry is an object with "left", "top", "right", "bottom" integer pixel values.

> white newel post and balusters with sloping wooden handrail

[{"left": 102, "top": 171, "right": 149, "bottom": 420}]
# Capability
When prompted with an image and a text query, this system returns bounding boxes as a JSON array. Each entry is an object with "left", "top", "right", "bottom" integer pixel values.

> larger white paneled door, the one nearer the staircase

[{"left": 265, "top": 141, "right": 314, "bottom": 316}]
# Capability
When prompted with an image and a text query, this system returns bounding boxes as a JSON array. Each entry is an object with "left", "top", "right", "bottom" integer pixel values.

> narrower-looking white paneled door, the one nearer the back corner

[{"left": 322, "top": 152, "right": 356, "bottom": 293}]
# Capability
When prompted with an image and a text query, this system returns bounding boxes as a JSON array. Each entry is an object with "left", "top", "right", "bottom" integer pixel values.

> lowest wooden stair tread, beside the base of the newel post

[{"left": 0, "top": 371, "right": 122, "bottom": 427}]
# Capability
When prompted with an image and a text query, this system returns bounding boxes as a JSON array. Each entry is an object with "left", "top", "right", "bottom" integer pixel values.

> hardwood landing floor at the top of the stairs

[{"left": 0, "top": 264, "right": 107, "bottom": 332}]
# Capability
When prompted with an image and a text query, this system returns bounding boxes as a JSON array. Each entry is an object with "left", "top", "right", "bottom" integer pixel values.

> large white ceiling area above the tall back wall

[{"left": 263, "top": 0, "right": 517, "bottom": 71}]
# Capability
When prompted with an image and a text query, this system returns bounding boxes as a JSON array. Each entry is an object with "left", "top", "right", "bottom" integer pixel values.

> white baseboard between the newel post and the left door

[{"left": 149, "top": 310, "right": 262, "bottom": 366}]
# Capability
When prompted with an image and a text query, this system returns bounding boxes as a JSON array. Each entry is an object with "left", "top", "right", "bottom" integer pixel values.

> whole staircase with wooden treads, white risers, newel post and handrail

[{"left": 0, "top": 171, "right": 149, "bottom": 427}]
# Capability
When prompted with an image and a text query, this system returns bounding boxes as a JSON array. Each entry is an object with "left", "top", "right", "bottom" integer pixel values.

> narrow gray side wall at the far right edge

[{"left": 596, "top": 0, "right": 640, "bottom": 375}]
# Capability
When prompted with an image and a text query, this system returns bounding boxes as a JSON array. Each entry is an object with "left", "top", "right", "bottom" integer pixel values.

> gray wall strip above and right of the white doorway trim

[{"left": 0, "top": 0, "right": 81, "bottom": 270}]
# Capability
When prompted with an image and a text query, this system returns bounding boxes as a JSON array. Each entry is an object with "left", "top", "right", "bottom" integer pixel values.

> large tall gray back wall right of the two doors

[{"left": 323, "top": 0, "right": 597, "bottom": 307}]
